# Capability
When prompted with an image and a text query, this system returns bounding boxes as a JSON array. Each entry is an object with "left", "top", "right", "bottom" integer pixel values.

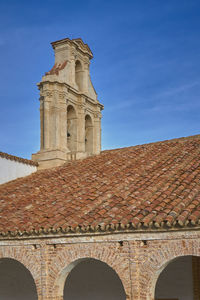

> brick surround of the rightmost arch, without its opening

[{"left": 140, "top": 240, "right": 200, "bottom": 300}]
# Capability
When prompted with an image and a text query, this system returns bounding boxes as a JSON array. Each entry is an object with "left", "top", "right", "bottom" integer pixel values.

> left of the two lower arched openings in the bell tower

[{"left": 67, "top": 105, "right": 77, "bottom": 152}]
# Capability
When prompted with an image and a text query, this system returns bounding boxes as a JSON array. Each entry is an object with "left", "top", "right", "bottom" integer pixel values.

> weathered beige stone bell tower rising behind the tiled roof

[{"left": 32, "top": 38, "right": 103, "bottom": 169}]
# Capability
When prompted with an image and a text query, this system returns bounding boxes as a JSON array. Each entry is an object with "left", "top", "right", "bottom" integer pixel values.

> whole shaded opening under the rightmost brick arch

[{"left": 155, "top": 256, "right": 200, "bottom": 300}]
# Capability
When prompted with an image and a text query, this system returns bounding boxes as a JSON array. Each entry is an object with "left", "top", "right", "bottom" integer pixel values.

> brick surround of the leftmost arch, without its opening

[{"left": 0, "top": 246, "right": 42, "bottom": 300}]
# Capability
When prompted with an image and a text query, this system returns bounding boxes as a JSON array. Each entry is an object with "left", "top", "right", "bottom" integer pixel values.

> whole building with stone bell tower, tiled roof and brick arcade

[{"left": 0, "top": 39, "right": 200, "bottom": 300}]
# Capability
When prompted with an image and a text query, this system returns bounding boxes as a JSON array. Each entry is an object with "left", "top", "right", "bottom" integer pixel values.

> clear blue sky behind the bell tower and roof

[{"left": 0, "top": 0, "right": 200, "bottom": 158}]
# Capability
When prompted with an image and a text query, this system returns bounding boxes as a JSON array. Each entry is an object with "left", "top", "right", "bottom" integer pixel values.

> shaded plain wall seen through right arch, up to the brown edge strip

[{"left": 156, "top": 256, "right": 193, "bottom": 300}]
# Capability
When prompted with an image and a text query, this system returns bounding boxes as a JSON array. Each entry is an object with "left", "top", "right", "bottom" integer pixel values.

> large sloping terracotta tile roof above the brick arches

[{"left": 0, "top": 135, "right": 200, "bottom": 236}]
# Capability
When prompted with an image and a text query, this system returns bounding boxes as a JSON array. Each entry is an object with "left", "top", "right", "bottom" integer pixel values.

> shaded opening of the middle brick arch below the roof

[{"left": 63, "top": 258, "right": 126, "bottom": 300}]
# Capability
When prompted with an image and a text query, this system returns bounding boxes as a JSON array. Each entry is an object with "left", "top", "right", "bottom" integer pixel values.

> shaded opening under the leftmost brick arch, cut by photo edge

[{"left": 0, "top": 258, "right": 38, "bottom": 300}]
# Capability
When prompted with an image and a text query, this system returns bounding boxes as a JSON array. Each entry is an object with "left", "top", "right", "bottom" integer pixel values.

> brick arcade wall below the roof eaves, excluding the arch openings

[{"left": 0, "top": 231, "right": 200, "bottom": 300}]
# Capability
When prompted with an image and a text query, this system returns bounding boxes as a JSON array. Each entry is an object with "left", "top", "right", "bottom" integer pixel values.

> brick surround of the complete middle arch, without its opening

[{"left": 49, "top": 245, "right": 131, "bottom": 300}]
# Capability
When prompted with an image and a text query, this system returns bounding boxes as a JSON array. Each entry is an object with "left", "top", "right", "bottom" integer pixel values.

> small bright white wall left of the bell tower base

[{"left": 0, "top": 157, "right": 37, "bottom": 184}]
